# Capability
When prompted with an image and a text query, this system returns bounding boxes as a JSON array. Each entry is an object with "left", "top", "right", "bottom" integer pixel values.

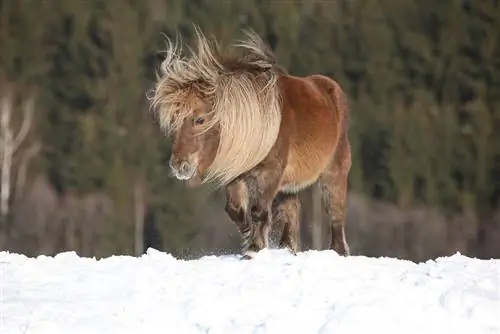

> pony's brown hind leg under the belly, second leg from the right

[{"left": 273, "top": 193, "right": 300, "bottom": 254}]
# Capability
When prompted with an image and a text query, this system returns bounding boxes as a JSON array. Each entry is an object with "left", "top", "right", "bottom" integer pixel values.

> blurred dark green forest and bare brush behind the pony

[{"left": 0, "top": 0, "right": 500, "bottom": 261}]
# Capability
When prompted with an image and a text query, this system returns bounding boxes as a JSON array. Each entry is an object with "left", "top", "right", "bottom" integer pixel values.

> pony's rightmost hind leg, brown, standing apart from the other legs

[{"left": 320, "top": 137, "right": 351, "bottom": 256}]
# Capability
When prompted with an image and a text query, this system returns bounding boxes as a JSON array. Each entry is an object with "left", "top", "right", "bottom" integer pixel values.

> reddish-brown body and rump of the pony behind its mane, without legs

[{"left": 279, "top": 75, "right": 346, "bottom": 192}]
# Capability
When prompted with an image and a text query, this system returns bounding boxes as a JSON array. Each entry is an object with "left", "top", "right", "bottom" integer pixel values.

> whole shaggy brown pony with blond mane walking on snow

[{"left": 150, "top": 27, "right": 351, "bottom": 258}]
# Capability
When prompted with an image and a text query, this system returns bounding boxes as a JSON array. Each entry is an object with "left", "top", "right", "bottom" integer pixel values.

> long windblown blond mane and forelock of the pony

[{"left": 151, "top": 27, "right": 281, "bottom": 186}]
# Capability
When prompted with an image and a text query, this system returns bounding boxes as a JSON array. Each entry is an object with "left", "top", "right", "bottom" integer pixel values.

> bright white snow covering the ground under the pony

[{"left": 0, "top": 249, "right": 500, "bottom": 334}]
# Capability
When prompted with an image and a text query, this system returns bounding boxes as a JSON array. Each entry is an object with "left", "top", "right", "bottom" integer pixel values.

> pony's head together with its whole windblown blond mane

[{"left": 147, "top": 29, "right": 281, "bottom": 186}]
